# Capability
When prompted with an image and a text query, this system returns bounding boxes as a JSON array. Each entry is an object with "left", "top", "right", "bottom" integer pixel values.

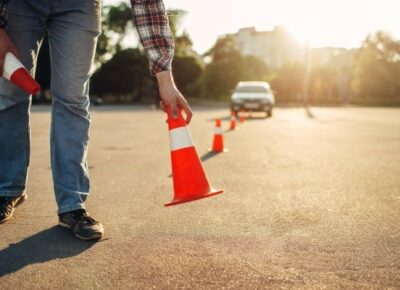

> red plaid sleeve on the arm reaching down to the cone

[{"left": 131, "top": 0, "right": 175, "bottom": 75}]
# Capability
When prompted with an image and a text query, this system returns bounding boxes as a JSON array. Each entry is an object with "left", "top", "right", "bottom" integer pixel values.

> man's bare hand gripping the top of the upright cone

[{"left": 156, "top": 71, "right": 193, "bottom": 124}]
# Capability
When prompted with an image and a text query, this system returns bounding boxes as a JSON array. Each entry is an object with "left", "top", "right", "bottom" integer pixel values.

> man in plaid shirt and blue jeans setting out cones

[{"left": 0, "top": 0, "right": 192, "bottom": 240}]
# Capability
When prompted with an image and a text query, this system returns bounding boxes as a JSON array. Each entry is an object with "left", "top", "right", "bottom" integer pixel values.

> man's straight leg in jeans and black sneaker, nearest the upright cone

[{"left": 48, "top": 0, "right": 104, "bottom": 240}]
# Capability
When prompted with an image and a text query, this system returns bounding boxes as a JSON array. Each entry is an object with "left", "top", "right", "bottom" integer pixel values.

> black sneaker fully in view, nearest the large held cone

[{"left": 58, "top": 209, "right": 104, "bottom": 240}]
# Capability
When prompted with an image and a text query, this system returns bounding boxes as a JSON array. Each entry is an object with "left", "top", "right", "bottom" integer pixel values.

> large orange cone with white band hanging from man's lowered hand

[{"left": 165, "top": 107, "right": 223, "bottom": 206}]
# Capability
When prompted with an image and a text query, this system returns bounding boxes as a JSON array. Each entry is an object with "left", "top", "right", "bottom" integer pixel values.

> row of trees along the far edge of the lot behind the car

[{"left": 86, "top": 2, "right": 400, "bottom": 103}]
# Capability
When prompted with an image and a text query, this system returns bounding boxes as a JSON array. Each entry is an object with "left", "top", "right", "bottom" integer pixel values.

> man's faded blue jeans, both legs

[{"left": 0, "top": 0, "right": 101, "bottom": 213}]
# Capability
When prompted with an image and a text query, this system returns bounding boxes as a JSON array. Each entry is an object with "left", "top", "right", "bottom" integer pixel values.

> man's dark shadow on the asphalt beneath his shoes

[{"left": 0, "top": 226, "right": 95, "bottom": 277}]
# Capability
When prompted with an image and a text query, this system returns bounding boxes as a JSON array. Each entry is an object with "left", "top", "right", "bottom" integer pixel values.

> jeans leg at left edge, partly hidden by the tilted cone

[{"left": 0, "top": 0, "right": 46, "bottom": 197}]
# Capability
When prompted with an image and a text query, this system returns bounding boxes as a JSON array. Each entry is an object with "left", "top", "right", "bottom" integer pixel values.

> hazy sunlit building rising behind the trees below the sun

[{"left": 230, "top": 26, "right": 356, "bottom": 102}]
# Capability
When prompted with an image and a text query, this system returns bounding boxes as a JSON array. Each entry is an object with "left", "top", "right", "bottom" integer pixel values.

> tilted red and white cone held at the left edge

[{"left": 3, "top": 52, "right": 40, "bottom": 95}]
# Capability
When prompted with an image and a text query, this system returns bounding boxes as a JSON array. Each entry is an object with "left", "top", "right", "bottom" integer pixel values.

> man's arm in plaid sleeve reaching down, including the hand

[{"left": 131, "top": 0, "right": 192, "bottom": 123}]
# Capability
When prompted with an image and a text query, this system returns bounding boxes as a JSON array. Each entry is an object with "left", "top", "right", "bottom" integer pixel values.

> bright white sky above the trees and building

[{"left": 104, "top": 0, "right": 400, "bottom": 53}]
